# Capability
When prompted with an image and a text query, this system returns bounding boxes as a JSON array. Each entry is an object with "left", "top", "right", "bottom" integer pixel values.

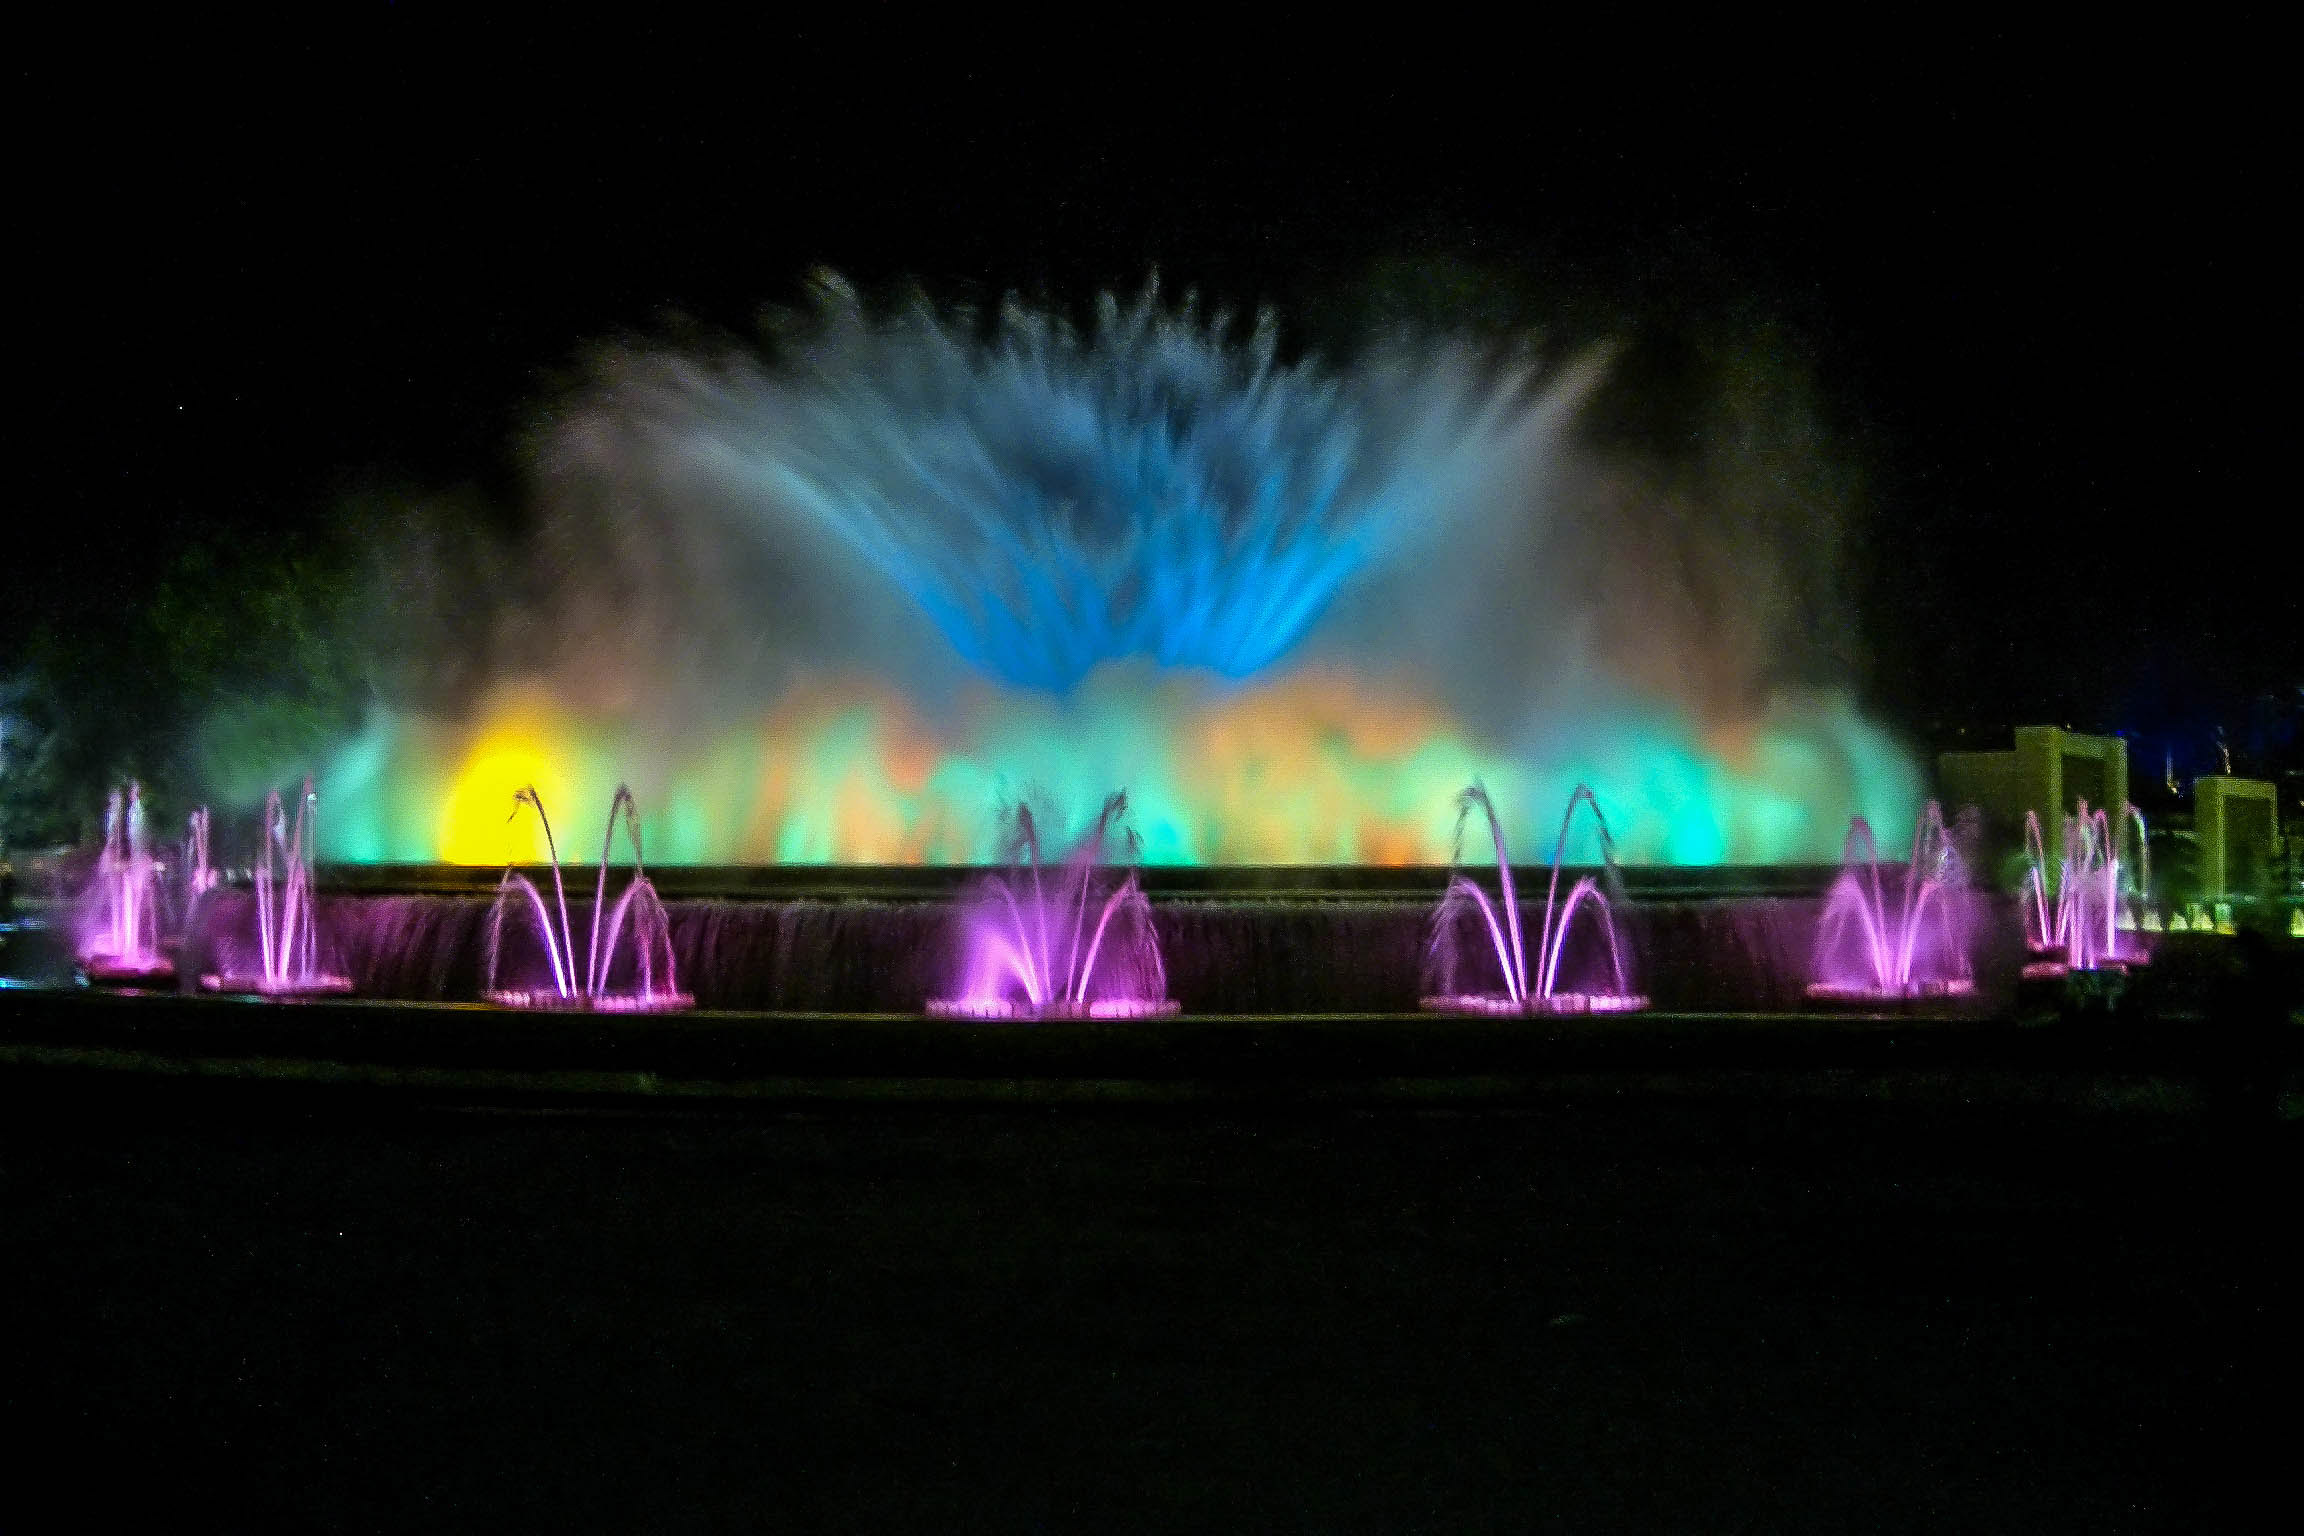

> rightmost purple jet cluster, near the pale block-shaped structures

[{"left": 2023, "top": 801, "right": 2152, "bottom": 981}]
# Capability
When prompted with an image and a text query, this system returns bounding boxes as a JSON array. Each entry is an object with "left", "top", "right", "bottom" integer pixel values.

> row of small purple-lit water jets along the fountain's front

[{"left": 81, "top": 781, "right": 2211, "bottom": 1020}]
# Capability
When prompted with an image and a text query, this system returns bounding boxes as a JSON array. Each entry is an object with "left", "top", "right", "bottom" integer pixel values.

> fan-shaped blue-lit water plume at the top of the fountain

[{"left": 560, "top": 281, "right": 1557, "bottom": 691}]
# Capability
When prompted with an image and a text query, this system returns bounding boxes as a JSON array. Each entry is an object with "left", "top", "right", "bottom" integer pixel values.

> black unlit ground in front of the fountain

[{"left": 0, "top": 1069, "right": 2299, "bottom": 1531}]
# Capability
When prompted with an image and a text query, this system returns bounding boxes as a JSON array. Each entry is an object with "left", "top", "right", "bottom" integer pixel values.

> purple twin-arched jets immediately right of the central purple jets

[{"left": 1424, "top": 783, "right": 1647, "bottom": 1013}]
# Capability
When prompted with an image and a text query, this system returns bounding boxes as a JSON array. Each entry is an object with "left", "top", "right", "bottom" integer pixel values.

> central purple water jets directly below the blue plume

[{"left": 929, "top": 794, "right": 1177, "bottom": 1020}]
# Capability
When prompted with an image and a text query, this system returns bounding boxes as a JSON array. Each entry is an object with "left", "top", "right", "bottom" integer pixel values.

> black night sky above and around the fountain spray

[{"left": 0, "top": 21, "right": 2304, "bottom": 764}]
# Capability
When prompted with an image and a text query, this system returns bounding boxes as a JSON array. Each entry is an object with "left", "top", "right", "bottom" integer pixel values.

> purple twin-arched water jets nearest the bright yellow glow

[{"left": 479, "top": 785, "right": 696, "bottom": 1013}]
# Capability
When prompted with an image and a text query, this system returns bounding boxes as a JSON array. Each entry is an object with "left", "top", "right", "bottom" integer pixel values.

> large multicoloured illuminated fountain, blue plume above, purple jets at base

[{"left": 9, "top": 286, "right": 1968, "bottom": 1018}]
